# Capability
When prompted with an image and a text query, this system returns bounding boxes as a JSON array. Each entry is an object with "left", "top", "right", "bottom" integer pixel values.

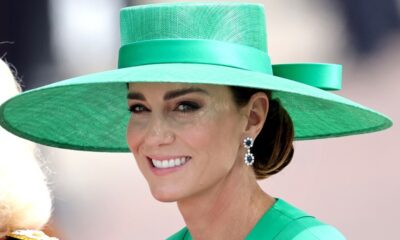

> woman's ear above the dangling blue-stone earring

[{"left": 243, "top": 92, "right": 269, "bottom": 139}]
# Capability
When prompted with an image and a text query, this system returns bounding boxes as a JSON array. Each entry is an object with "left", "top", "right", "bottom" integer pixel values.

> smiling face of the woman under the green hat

[{"left": 127, "top": 83, "right": 246, "bottom": 201}]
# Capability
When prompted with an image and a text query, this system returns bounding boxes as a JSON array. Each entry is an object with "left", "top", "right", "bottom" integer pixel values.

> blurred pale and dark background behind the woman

[{"left": 0, "top": 0, "right": 400, "bottom": 240}]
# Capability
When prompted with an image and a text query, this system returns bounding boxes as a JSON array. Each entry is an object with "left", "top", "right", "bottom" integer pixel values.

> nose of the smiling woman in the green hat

[{"left": 144, "top": 117, "right": 175, "bottom": 147}]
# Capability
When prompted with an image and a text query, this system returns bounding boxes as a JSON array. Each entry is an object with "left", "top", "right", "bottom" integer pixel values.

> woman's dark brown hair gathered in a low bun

[{"left": 230, "top": 87, "right": 294, "bottom": 179}]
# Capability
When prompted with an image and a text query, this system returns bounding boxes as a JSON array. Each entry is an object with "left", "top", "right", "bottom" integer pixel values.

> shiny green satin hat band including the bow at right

[{"left": 118, "top": 39, "right": 342, "bottom": 90}]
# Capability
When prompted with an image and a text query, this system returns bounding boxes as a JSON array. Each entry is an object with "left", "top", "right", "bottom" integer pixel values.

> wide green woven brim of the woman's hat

[{"left": 0, "top": 63, "right": 392, "bottom": 152}]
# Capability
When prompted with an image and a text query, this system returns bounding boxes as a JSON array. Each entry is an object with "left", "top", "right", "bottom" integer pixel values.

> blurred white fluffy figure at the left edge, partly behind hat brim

[{"left": 0, "top": 59, "right": 55, "bottom": 239}]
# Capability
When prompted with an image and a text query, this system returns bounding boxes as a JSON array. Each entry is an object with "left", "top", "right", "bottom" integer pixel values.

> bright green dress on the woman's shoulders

[{"left": 167, "top": 199, "right": 346, "bottom": 240}]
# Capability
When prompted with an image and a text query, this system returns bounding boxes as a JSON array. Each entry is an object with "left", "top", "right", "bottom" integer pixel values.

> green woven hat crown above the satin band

[{"left": 120, "top": 2, "right": 267, "bottom": 52}]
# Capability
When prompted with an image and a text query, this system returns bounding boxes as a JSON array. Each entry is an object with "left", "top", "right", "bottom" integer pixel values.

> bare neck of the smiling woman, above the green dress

[{"left": 178, "top": 159, "right": 275, "bottom": 240}]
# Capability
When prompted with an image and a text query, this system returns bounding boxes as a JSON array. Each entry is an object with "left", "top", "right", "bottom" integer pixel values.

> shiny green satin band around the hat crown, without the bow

[{"left": 118, "top": 39, "right": 272, "bottom": 74}]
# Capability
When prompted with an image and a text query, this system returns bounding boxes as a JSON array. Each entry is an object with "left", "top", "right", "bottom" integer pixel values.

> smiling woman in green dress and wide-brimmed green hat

[{"left": 0, "top": 3, "right": 391, "bottom": 239}]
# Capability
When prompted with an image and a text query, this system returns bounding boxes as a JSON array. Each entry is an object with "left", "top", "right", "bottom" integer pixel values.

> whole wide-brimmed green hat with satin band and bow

[{"left": 0, "top": 3, "right": 392, "bottom": 152}]
